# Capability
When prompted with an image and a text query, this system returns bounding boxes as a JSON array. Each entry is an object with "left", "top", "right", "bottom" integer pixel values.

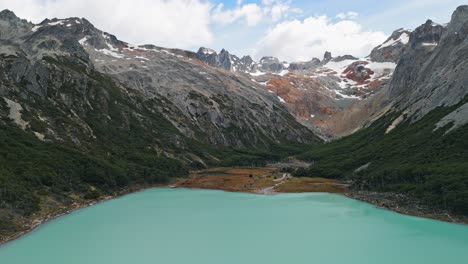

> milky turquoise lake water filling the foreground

[{"left": 0, "top": 189, "right": 468, "bottom": 264}]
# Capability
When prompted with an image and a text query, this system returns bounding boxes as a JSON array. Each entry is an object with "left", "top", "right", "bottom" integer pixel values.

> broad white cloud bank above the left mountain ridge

[{"left": 0, "top": 0, "right": 213, "bottom": 48}]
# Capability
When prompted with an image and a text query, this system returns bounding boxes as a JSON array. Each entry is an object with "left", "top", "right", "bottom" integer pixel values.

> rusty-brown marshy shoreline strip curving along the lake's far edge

[{"left": 0, "top": 168, "right": 468, "bottom": 247}]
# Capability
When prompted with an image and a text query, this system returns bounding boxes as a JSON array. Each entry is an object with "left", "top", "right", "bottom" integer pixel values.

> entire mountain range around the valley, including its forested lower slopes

[{"left": 0, "top": 6, "right": 468, "bottom": 239}]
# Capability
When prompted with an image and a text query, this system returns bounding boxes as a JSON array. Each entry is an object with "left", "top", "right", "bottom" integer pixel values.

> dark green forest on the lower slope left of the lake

[{"left": 0, "top": 117, "right": 314, "bottom": 233}]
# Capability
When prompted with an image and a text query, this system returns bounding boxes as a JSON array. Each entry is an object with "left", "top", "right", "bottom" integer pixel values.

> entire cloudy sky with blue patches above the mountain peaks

[{"left": 0, "top": 0, "right": 466, "bottom": 61}]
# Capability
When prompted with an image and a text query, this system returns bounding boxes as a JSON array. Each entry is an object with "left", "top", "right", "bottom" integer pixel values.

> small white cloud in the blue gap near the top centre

[{"left": 212, "top": 4, "right": 263, "bottom": 26}]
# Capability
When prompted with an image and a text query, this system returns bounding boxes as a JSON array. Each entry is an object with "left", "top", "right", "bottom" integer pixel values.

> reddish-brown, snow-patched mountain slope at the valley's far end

[{"left": 197, "top": 45, "right": 402, "bottom": 139}]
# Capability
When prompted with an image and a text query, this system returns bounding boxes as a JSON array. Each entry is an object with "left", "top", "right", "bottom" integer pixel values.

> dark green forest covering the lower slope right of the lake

[{"left": 295, "top": 99, "right": 468, "bottom": 215}]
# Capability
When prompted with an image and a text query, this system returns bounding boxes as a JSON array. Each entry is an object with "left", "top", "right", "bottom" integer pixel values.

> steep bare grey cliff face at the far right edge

[{"left": 387, "top": 6, "right": 468, "bottom": 132}]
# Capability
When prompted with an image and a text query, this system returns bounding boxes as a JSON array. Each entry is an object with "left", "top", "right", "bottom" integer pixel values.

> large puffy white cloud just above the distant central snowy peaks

[{"left": 255, "top": 16, "right": 387, "bottom": 61}]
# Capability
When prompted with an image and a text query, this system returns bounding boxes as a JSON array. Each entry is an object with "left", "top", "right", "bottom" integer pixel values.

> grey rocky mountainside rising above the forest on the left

[{"left": 0, "top": 11, "right": 315, "bottom": 155}]
